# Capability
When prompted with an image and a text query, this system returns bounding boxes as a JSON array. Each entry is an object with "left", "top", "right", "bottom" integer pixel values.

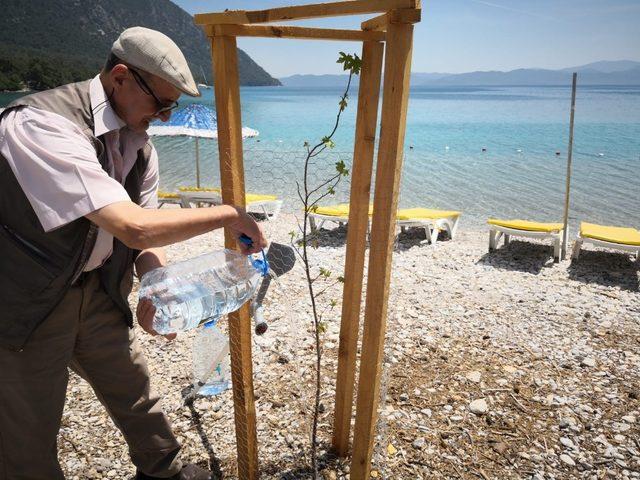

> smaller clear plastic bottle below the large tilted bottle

[{"left": 193, "top": 322, "right": 231, "bottom": 396}]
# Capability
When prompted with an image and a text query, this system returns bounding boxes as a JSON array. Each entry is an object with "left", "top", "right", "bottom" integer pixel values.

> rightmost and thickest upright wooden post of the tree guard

[{"left": 351, "top": 20, "right": 413, "bottom": 480}]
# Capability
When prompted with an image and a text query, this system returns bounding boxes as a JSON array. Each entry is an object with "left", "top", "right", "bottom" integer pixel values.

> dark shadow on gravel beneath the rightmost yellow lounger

[{"left": 568, "top": 250, "right": 640, "bottom": 292}]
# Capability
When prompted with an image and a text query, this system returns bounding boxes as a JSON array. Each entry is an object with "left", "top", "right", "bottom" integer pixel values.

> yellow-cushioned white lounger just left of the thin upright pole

[{"left": 487, "top": 218, "right": 564, "bottom": 263}]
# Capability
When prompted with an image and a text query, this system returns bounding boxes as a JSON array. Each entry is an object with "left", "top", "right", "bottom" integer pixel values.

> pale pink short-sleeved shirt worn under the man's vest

[{"left": 0, "top": 76, "right": 159, "bottom": 271}]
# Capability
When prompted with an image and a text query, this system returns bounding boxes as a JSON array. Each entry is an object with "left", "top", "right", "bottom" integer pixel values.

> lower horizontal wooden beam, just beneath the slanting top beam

[{"left": 205, "top": 25, "right": 385, "bottom": 42}]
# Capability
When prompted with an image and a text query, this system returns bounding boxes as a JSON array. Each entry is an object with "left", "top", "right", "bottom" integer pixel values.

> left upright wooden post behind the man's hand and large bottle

[{"left": 211, "top": 37, "right": 258, "bottom": 480}]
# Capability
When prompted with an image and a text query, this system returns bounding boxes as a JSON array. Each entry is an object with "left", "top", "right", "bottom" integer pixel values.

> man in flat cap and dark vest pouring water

[{"left": 0, "top": 27, "right": 266, "bottom": 480}]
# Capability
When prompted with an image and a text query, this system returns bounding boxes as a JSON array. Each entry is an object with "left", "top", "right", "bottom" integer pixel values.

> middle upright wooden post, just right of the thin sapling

[{"left": 332, "top": 42, "right": 384, "bottom": 457}]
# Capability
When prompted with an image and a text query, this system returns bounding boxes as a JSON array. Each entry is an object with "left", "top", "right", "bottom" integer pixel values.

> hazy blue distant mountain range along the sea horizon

[{"left": 280, "top": 60, "right": 640, "bottom": 87}]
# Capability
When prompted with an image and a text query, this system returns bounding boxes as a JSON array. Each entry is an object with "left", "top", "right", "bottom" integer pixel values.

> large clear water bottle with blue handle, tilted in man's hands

[{"left": 139, "top": 249, "right": 269, "bottom": 335}]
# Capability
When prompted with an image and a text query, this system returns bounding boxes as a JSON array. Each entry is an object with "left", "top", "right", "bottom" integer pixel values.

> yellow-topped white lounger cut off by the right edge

[{"left": 572, "top": 222, "right": 640, "bottom": 263}]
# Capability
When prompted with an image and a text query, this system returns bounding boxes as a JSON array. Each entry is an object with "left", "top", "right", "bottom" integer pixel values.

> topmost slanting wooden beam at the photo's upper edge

[{"left": 193, "top": 0, "right": 420, "bottom": 25}]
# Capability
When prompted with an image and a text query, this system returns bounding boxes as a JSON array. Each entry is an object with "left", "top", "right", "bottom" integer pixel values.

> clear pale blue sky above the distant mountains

[{"left": 172, "top": 0, "right": 640, "bottom": 77}]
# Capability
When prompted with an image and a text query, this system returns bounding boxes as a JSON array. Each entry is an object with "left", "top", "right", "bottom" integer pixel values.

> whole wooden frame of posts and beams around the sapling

[{"left": 200, "top": 0, "right": 420, "bottom": 480}]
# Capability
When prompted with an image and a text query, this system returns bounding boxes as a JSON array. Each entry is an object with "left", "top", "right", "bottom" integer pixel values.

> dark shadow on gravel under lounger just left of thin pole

[{"left": 476, "top": 240, "right": 554, "bottom": 275}]
